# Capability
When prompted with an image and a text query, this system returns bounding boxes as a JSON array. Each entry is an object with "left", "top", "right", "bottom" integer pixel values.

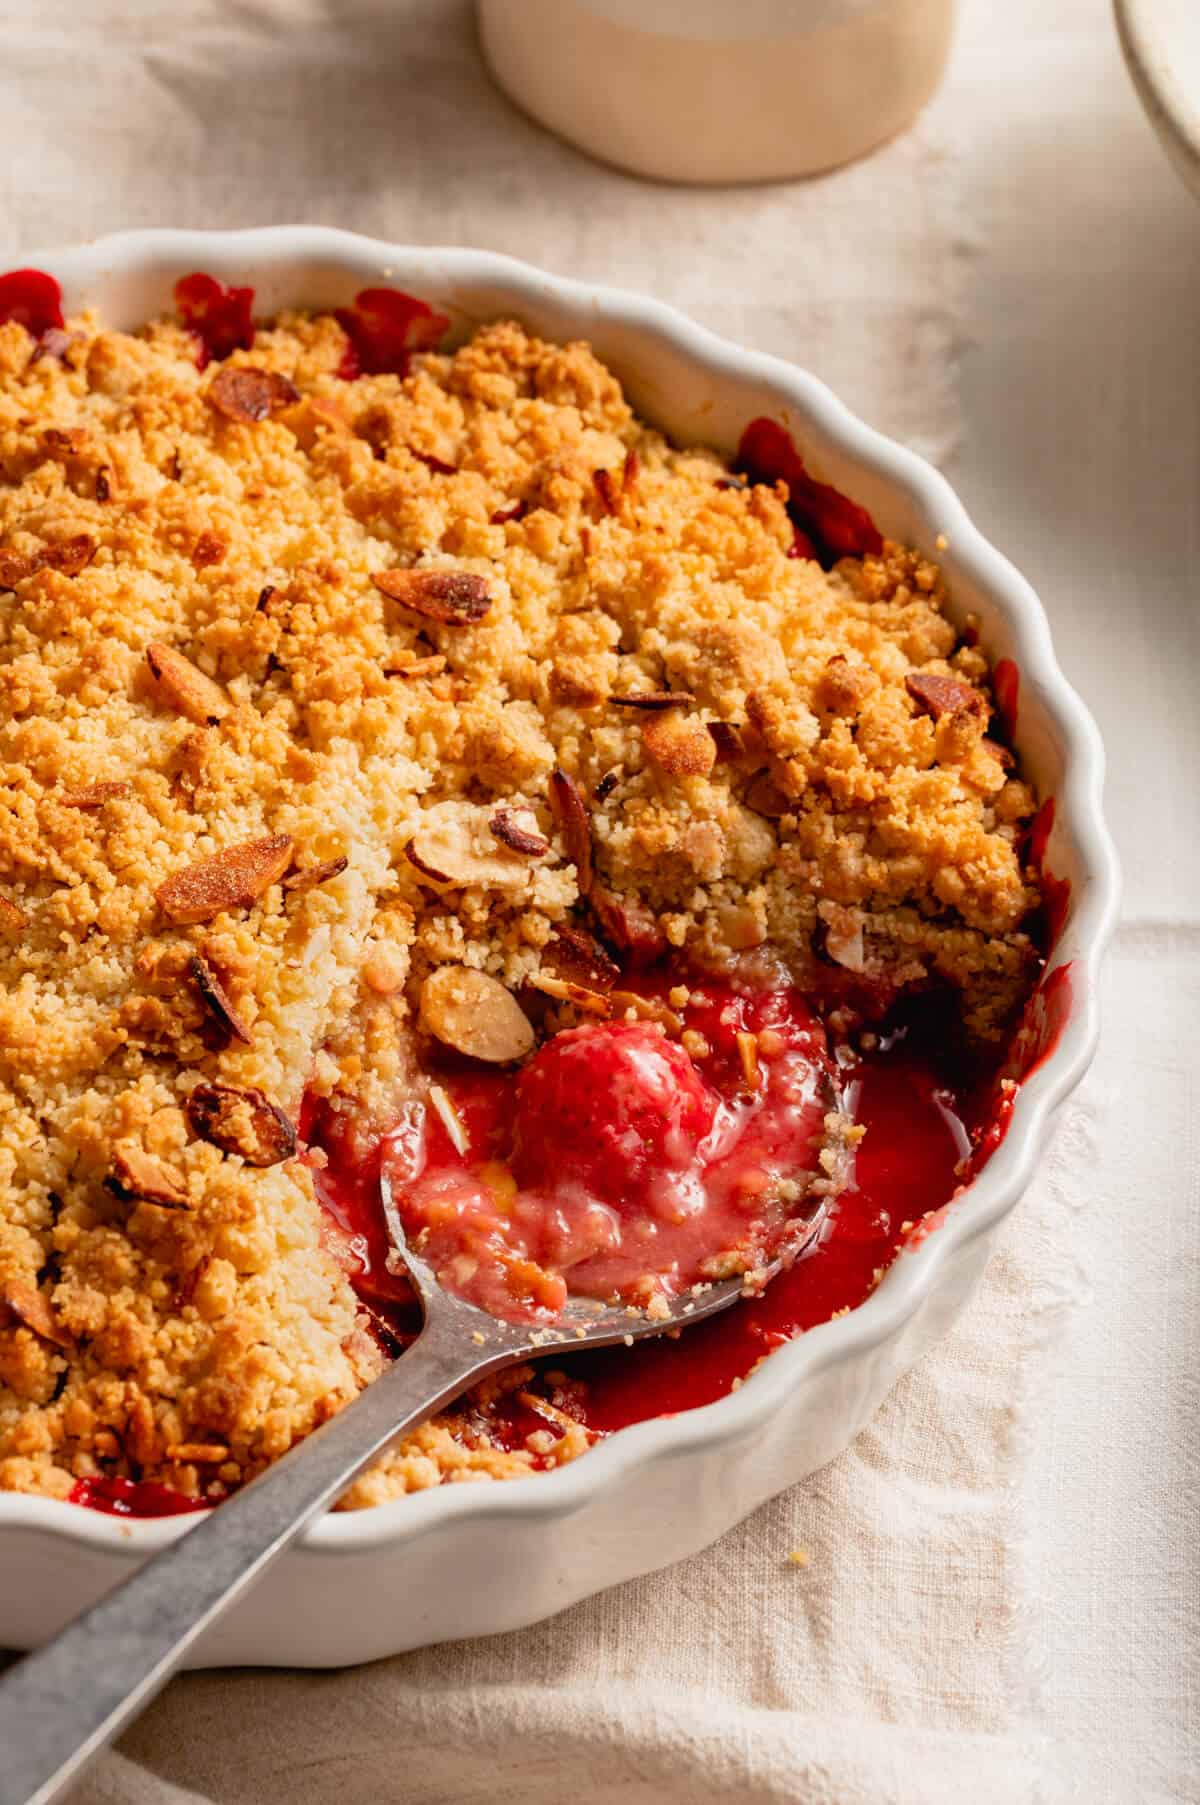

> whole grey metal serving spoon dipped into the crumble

[{"left": 0, "top": 1175, "right": 826, "bottom": 1805}]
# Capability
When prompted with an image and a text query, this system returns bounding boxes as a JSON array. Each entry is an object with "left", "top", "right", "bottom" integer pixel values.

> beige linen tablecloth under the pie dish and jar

[{"left": 0, "top": 0, "right": 1200, "bottom": 1805}]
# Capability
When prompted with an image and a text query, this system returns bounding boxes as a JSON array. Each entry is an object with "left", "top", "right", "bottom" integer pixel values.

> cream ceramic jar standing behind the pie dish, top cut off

[{"left": 478, "top": 0, "right": 955, "bottom": 182}]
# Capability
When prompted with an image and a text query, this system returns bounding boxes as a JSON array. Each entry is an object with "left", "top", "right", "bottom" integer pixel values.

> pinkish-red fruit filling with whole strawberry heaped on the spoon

[{"left": 371, "top": 984, "right": 835, "bottom": 1318}]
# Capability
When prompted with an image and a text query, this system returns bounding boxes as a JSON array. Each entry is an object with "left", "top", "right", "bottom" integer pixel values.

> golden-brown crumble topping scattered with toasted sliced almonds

[{"left": 0, "top": 291, "right": 1039, "bottom": 1505}]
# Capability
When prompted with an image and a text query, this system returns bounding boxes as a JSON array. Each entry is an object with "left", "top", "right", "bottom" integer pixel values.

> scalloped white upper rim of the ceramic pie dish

[{"left": 0, "top": 226, "right": 1119, "bottom": 1558}]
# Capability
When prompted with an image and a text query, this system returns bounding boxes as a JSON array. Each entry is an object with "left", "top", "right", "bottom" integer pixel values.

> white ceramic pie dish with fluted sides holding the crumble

[{"left": 0, "top": 227, "right": 1119, "bottom": 1666}]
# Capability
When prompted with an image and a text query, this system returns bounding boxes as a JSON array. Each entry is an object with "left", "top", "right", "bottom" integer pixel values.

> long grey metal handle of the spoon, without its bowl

[{"left": 0, "top": 1309, "right": 527, "bottom": 1805}]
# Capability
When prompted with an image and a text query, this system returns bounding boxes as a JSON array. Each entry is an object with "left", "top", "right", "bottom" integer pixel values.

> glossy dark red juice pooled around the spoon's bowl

[{"left": 306, "top": 982, "right": 1011, "bottom": 1446}]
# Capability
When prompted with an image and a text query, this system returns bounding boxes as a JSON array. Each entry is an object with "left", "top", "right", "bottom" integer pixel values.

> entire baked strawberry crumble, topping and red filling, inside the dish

[{"left": 0, "top": 271, "right": 1047, "bottom": 1514}]
